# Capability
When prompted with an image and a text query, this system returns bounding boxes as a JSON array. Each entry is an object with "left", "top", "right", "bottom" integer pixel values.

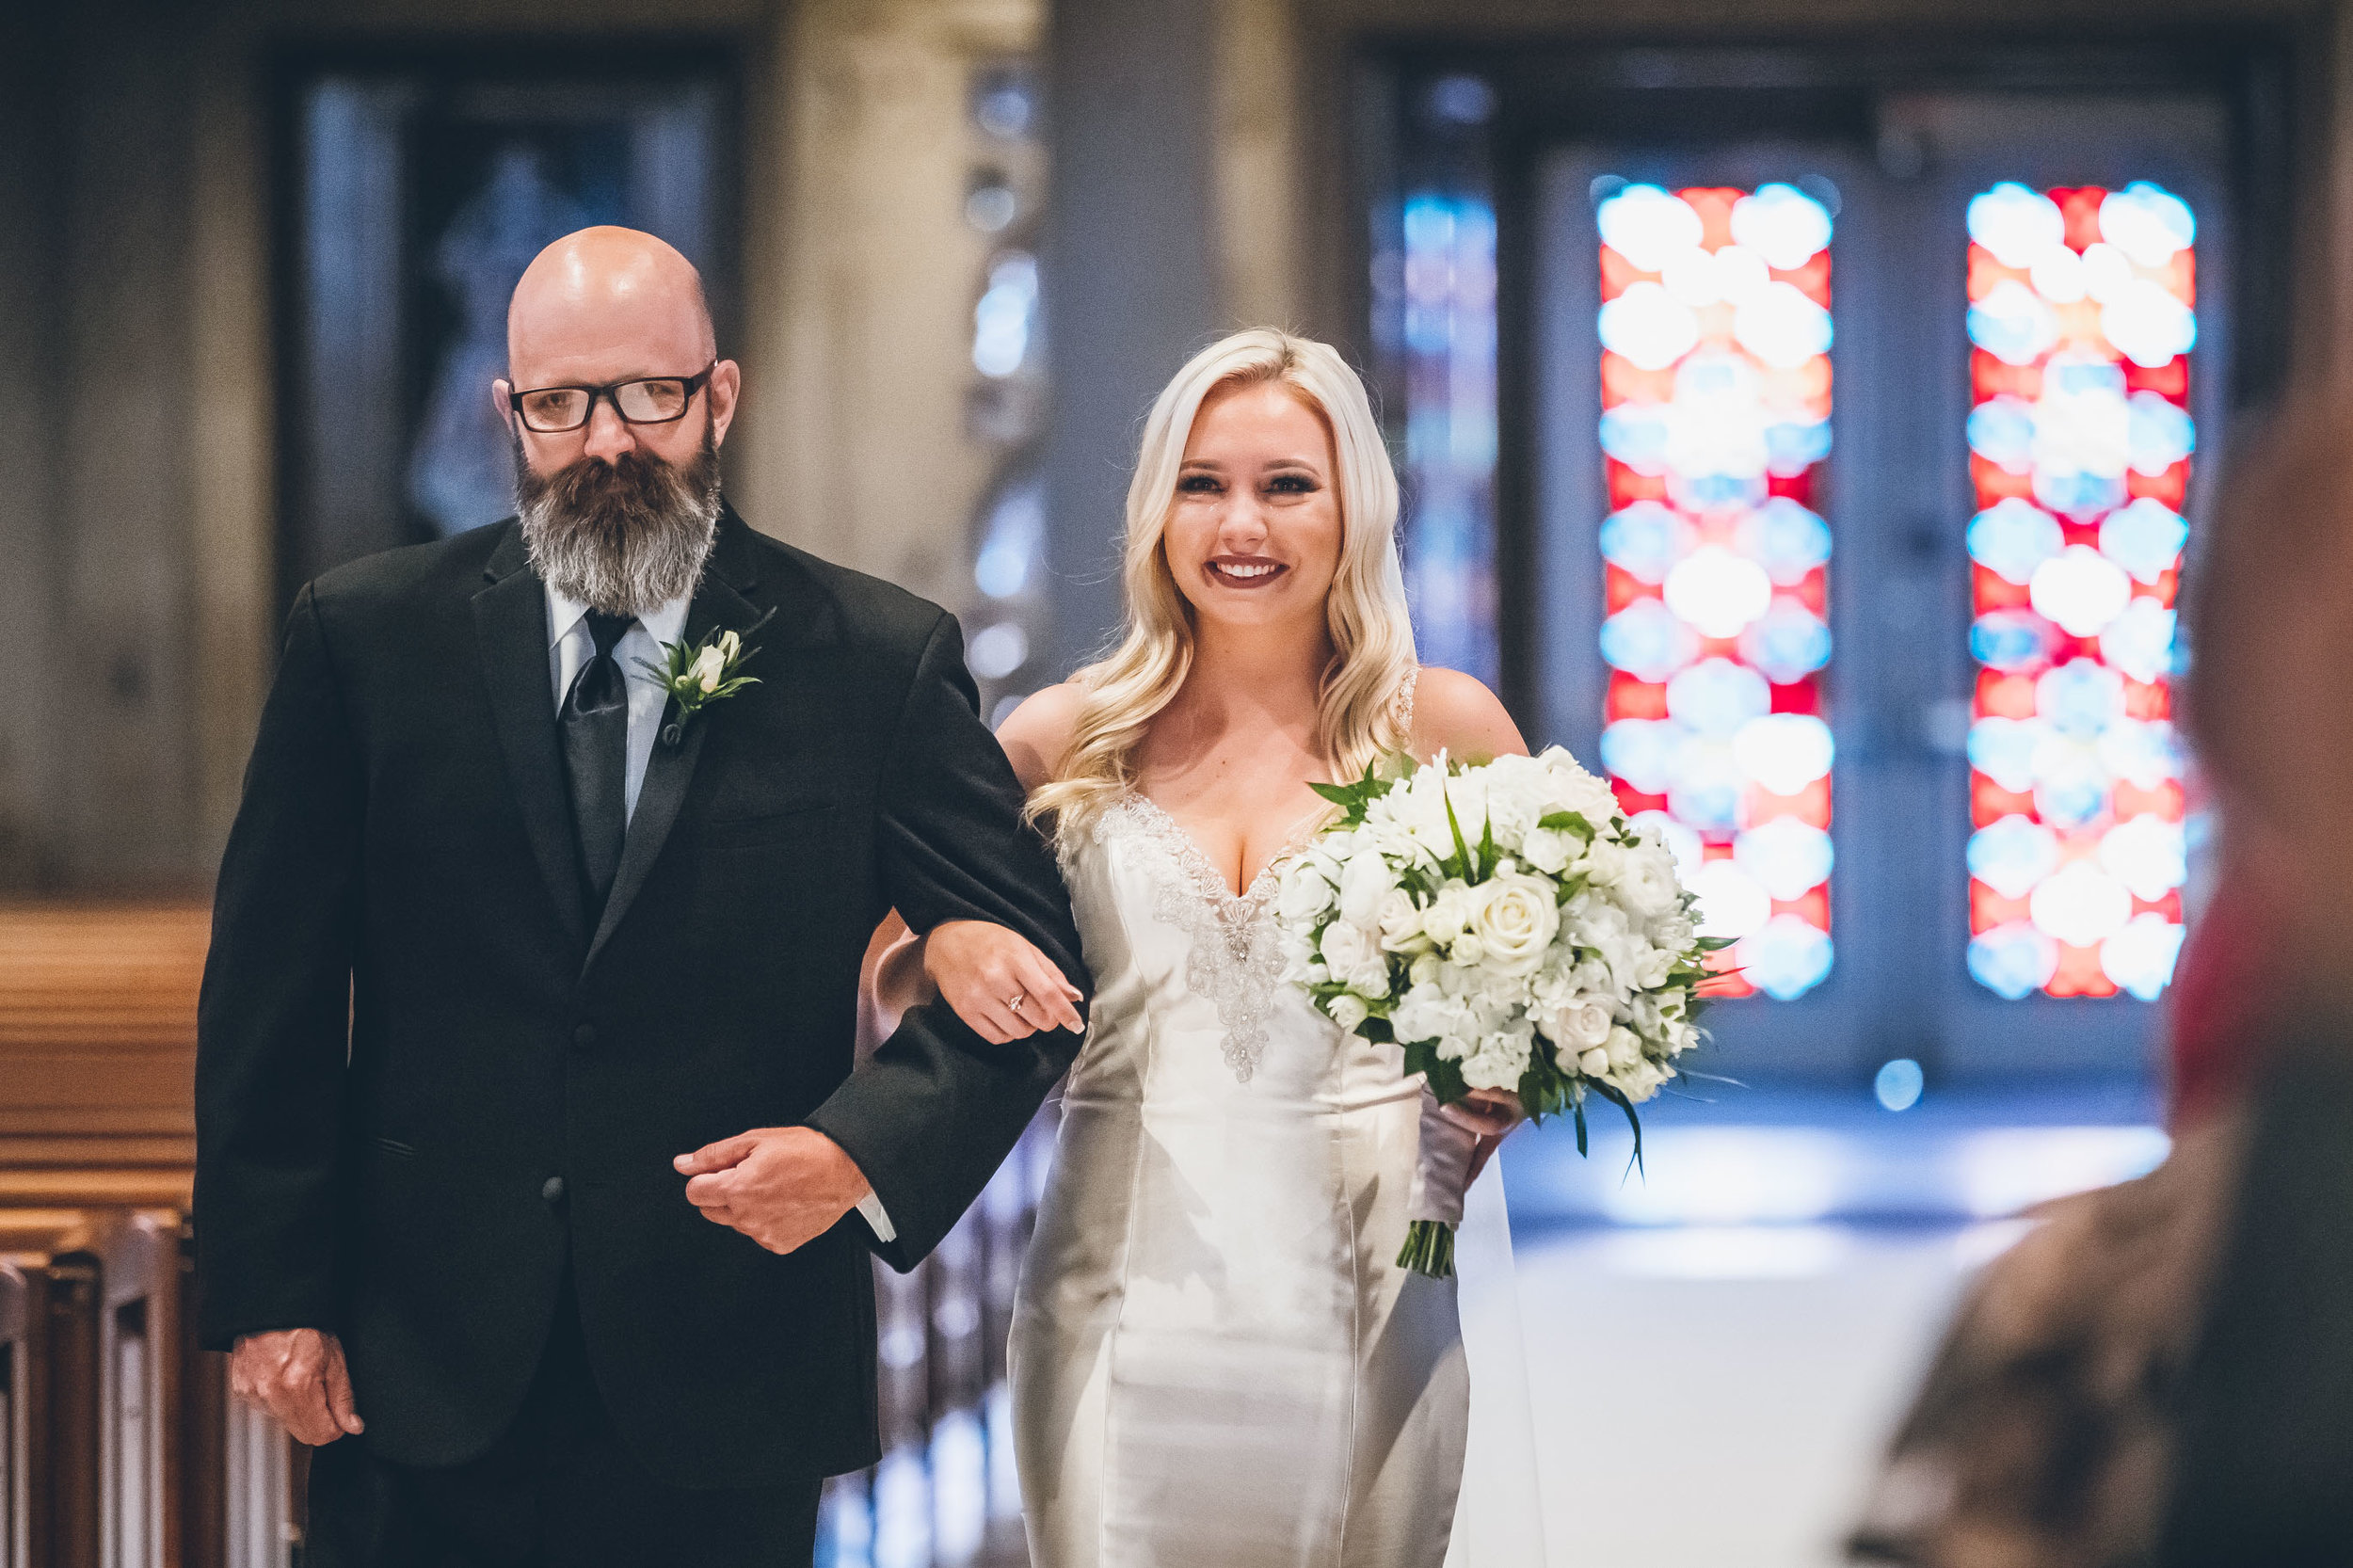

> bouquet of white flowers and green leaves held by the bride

[{"left": 1278, "top": 746, "right": 1727, "bottom": 1278}]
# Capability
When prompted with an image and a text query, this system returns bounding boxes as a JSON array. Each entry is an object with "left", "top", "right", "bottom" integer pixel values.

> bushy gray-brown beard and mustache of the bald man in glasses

[{"left": 516, "top": 426, "right": 720, "bottom": 615}]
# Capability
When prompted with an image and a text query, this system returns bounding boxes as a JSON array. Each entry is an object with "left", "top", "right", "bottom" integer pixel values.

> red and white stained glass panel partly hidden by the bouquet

[{"left": 1595, "top": 182, "right": 1833, "bottom": 1000}]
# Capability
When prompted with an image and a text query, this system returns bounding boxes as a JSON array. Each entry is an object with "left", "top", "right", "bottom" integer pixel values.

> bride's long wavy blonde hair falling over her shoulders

[{"left": 1029, "top": 328, "right": 1417, "bottom": 829}]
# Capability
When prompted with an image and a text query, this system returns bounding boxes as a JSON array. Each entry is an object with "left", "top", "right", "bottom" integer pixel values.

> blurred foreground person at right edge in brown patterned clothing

[{"left": 1852, "top": 395, "right": 2353, "bottom": 1568}]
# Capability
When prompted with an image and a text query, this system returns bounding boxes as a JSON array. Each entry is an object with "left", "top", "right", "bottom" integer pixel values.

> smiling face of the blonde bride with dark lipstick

[{"left": 1160, "top": 381, "right": 1341, "bottom": 626}]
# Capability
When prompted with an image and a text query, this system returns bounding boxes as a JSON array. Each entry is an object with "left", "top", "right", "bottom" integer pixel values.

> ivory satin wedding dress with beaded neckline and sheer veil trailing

[{"left": 1012, "top": 793, "right": 1544, "bottom": 1568}]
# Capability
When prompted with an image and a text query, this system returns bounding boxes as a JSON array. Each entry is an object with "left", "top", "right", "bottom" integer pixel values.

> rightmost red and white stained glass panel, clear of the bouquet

[{"left": 1967, "top": 182, "right": 2198, "bottom": 1000}]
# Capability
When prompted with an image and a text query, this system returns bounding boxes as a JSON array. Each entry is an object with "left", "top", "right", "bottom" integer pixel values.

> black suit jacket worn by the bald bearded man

[{"left": 196, "top": 511, "right": 1085, "bottom": 1485}]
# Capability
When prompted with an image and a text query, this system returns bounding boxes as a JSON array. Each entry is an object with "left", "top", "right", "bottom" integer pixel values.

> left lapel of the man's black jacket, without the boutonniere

[{"left": 473, "top": 525, "right": 588, "bottom": 944}]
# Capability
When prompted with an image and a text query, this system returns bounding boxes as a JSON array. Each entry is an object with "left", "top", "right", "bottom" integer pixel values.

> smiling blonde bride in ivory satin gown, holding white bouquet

[{"left": 908, "top": 329, "right": 1542, "bottom": 1568}]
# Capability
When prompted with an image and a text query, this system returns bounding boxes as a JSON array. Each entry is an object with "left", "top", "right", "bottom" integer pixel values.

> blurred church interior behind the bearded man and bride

[{"left": 0, "top": 0, "right": 2353, "bottom": 1568}]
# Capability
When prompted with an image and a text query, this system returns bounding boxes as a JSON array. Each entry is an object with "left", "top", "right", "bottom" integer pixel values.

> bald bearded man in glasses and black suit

[{"left": 196, "top": 229, "right": 1085, "bottom": 1568}]
